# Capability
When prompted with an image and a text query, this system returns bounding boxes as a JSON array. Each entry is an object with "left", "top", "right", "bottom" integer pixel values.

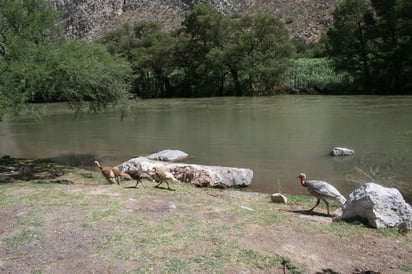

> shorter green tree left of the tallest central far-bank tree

[{"left": 100, "top": 21, "right": 176, "bottom": 97}]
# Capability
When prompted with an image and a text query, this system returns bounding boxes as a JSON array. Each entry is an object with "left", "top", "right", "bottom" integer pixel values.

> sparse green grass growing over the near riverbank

[{"left": 0, "top": 165, "right": 411, "bottom": 273}]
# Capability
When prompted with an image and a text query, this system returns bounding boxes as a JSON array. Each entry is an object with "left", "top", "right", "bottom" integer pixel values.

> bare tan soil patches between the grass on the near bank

[{"left": 0, "top": 159, "right": 412, "bottom": 273}]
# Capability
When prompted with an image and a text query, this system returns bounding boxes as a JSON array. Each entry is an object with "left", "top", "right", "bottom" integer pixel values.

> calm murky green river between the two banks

[{"left": 0, "top": 95, "right": 412, "bottom": 201}]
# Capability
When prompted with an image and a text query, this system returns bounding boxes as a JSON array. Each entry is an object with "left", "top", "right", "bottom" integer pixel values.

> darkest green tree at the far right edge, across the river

[{"left": 371, "top": 0, "right": 412, "bottom": 92}]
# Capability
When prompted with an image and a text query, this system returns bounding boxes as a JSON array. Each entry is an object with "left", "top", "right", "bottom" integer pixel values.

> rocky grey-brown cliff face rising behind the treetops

[{"left": 49, "top": 0, "right": 342, "bottom": 41}]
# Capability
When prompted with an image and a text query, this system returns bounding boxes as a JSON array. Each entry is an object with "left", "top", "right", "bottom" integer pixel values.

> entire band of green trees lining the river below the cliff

[{"left": 0, "top": 0, "right": 412, "bottom": 117}]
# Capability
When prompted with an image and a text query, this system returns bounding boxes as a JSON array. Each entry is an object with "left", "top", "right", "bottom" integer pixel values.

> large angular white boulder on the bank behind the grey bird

[{"left": 339, "top": 183, "right": 412, "bottom": 230}]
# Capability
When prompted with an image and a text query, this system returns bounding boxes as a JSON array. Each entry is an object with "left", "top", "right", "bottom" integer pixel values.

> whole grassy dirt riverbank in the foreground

[{"left": 0, "top": 161, "right": 412, "bottom": 273}]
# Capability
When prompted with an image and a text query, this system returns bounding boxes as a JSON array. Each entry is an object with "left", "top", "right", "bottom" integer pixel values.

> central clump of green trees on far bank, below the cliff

[{"left": 100, "top": 4, "right": 292, "bottom": 97}]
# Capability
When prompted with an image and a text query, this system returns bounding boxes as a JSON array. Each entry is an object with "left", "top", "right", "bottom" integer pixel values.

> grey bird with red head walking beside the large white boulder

[{"left": 298, "top": 173, "right": 346, "bottom": 215}]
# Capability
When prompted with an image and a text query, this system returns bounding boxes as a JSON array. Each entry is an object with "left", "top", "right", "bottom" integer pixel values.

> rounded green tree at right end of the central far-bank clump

[{"left": 223, "top": 15, "right": 293, "bottom": 95}]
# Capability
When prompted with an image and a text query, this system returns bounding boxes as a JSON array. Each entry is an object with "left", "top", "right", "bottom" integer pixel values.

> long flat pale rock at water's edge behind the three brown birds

[{"left": 116, "top": 157, "right": 253, "bottom": 188}]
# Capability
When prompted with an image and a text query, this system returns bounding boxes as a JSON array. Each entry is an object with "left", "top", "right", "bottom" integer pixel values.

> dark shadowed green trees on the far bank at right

[{"left": 327, "top": 0, "right": 412, "bottom": 93}]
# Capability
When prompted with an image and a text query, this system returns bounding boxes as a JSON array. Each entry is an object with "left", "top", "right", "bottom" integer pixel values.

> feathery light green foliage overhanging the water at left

[{"left": 0, "top": 0, "right": 130, "bottom": 117}]
